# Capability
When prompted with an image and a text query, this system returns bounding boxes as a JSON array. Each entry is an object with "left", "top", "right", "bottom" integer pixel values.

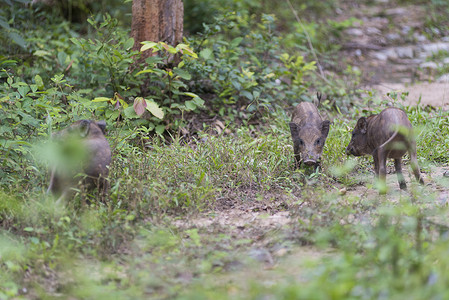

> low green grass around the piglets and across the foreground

[{"left": 0, "top": 102, "right": 449, "bottom": 299}]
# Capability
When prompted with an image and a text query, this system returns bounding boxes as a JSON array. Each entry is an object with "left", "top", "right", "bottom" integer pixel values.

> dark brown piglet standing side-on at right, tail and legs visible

[{"left": 346, "top": 107, "right": 424, "bottom": 189}]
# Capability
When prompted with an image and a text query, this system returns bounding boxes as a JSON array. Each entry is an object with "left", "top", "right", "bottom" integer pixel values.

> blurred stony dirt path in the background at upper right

[{"left": 339, "top": 0, "right": 449, "bottom": 109}]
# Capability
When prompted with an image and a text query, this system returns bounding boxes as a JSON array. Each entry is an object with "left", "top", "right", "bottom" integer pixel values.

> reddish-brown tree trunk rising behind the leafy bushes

[{"left": 131, "top": 0, "right": 184, "bottom": 59}]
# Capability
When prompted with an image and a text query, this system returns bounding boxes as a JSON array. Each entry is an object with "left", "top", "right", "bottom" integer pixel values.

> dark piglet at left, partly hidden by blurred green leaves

[{"left": 47, "top": 120, "right": 111, "bottom": 200}]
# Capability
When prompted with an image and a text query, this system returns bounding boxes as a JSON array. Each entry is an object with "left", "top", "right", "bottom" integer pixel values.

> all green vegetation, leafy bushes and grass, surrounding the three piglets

[{"left": 0, "top": 0, "right": 449, "bottom": 299}]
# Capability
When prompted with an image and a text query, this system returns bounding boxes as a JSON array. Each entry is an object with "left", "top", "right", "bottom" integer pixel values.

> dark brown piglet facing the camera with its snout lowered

[{"left": 289, "top": 102, "right": 330, "bottom": 168}]
